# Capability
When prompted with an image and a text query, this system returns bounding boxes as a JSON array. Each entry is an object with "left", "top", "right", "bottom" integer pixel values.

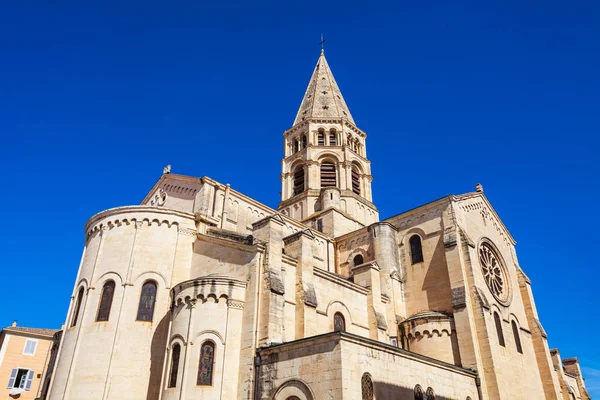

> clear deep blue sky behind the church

[{"left": 0, "top": 1, "right": 600, "bottom": 396}]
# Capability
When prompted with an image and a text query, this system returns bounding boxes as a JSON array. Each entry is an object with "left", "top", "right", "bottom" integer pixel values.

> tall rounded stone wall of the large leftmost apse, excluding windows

[{"left": 50, "top": 206, "right": 195, "bottom": 400}]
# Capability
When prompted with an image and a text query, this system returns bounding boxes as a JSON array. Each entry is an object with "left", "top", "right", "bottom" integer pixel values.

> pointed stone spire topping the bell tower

[{"left": 294, "top": 49, "right": 354, "bottom": 125}]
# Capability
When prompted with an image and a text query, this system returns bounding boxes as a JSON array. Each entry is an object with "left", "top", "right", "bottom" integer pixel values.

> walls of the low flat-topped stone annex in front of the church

[{"left": 258, "top": 333, "right": 478, "bottom": 400}]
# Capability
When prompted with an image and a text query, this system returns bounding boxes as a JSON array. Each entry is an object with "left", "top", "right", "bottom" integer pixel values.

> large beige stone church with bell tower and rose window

[{"left": 47, "top": 52, "right": 590, "bottom": 400}]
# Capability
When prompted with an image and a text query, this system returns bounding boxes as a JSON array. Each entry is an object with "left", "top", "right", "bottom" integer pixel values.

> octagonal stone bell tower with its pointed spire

[{"left": 278, "top": 50, "right": 379, "bottom": 237}]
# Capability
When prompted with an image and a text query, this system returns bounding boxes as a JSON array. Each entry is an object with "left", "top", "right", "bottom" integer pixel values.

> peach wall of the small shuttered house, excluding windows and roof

[{"left": 0, "top": 330, "right": 52, "bottom": 400}]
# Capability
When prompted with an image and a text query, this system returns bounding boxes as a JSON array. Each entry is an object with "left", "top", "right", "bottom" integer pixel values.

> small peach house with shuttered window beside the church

[{"left": 0, "top": 321, "right": 58, "bottom": 400}]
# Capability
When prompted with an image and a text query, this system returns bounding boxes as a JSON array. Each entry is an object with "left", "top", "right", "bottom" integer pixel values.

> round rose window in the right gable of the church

[{"left": 479, "top": 242, "right": 510, "bottom": 304}]
